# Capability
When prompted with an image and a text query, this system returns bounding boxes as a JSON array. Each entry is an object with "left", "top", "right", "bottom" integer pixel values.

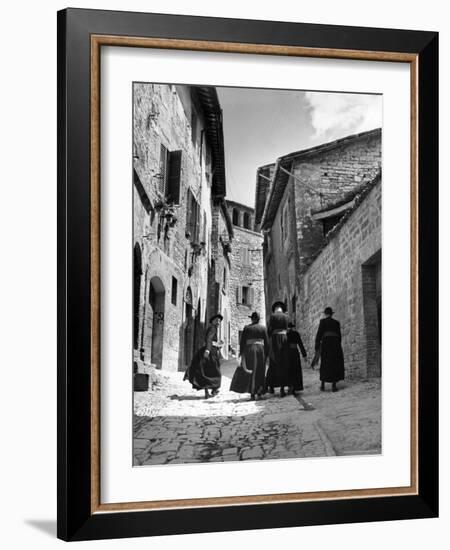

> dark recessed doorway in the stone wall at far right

[{"left": 362, "top": 250, "right": 382, "bottom": 377}]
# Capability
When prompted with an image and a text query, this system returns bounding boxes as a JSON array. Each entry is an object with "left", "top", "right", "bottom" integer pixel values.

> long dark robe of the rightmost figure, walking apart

[{"left": 315, "top": 317, "right": 344, "bottom": 382}]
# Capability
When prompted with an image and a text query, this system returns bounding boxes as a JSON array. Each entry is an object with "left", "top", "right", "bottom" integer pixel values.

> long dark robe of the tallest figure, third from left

[{"left": 266, "top": 312, "right": 289, "bottom": 388}]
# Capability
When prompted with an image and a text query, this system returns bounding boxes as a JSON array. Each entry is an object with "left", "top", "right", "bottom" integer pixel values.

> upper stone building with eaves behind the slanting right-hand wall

[{"left": 264, "top": 130, "right": 381, "bottom": 344}]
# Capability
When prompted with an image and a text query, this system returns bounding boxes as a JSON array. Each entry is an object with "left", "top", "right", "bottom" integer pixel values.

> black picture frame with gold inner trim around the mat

[{"left": 58, "top": 9, "right": 438, "bottom": 540}]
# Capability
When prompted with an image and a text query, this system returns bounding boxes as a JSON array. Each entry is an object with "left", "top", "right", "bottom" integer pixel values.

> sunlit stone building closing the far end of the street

[{"left": 227, "top": 201, "right": 265, "bottom": 354}]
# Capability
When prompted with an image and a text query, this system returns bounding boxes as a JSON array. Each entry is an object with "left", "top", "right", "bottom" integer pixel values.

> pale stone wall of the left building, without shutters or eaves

[{"left": 133, "top": 83, "right": 211, "bottom": 370}]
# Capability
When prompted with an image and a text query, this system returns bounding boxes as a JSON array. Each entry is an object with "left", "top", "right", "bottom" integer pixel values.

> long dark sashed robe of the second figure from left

[{"left": 230, "top": 323, "right": 269, "bottom": 395}]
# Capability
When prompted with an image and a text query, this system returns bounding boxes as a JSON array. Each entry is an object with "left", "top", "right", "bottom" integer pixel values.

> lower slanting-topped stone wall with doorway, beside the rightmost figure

[{"left": 298, "top": 182, "right": 381, "bottom": 378}]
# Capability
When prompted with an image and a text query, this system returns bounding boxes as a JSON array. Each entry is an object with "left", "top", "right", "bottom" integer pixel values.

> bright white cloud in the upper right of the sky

[{"left": 304, "top": 92, "right": 382, "bottom": 141}]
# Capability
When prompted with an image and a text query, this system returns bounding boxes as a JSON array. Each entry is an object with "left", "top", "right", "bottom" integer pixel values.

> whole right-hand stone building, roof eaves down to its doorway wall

[{"left": 255, "top": 129, "right": 381, "bottom": 377}]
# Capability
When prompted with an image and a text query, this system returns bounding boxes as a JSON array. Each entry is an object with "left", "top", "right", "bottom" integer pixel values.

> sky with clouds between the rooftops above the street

[{"left": 217, "top": 88, "right": 382, "bottom": 207}]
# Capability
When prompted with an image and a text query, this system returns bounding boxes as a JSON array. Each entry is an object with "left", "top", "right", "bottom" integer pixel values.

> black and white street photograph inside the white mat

[{"left": 130, "top": 82, "right": 382, "bottom": 466}]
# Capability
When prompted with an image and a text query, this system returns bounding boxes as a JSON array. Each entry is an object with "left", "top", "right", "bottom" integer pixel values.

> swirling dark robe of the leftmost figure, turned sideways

[{"left": 184, "top": 324, "right": 222, "bottom": 390}]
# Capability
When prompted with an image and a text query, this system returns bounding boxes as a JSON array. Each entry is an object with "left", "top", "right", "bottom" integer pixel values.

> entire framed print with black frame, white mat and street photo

[{"left": 58, "top": 9, "right": 438, "bottom": 540}]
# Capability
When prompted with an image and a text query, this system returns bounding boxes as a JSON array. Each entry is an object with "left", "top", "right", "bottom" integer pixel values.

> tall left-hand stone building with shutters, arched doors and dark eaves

[{"left": 133, "top": 83, "right": 227, "bottom": 370}]
